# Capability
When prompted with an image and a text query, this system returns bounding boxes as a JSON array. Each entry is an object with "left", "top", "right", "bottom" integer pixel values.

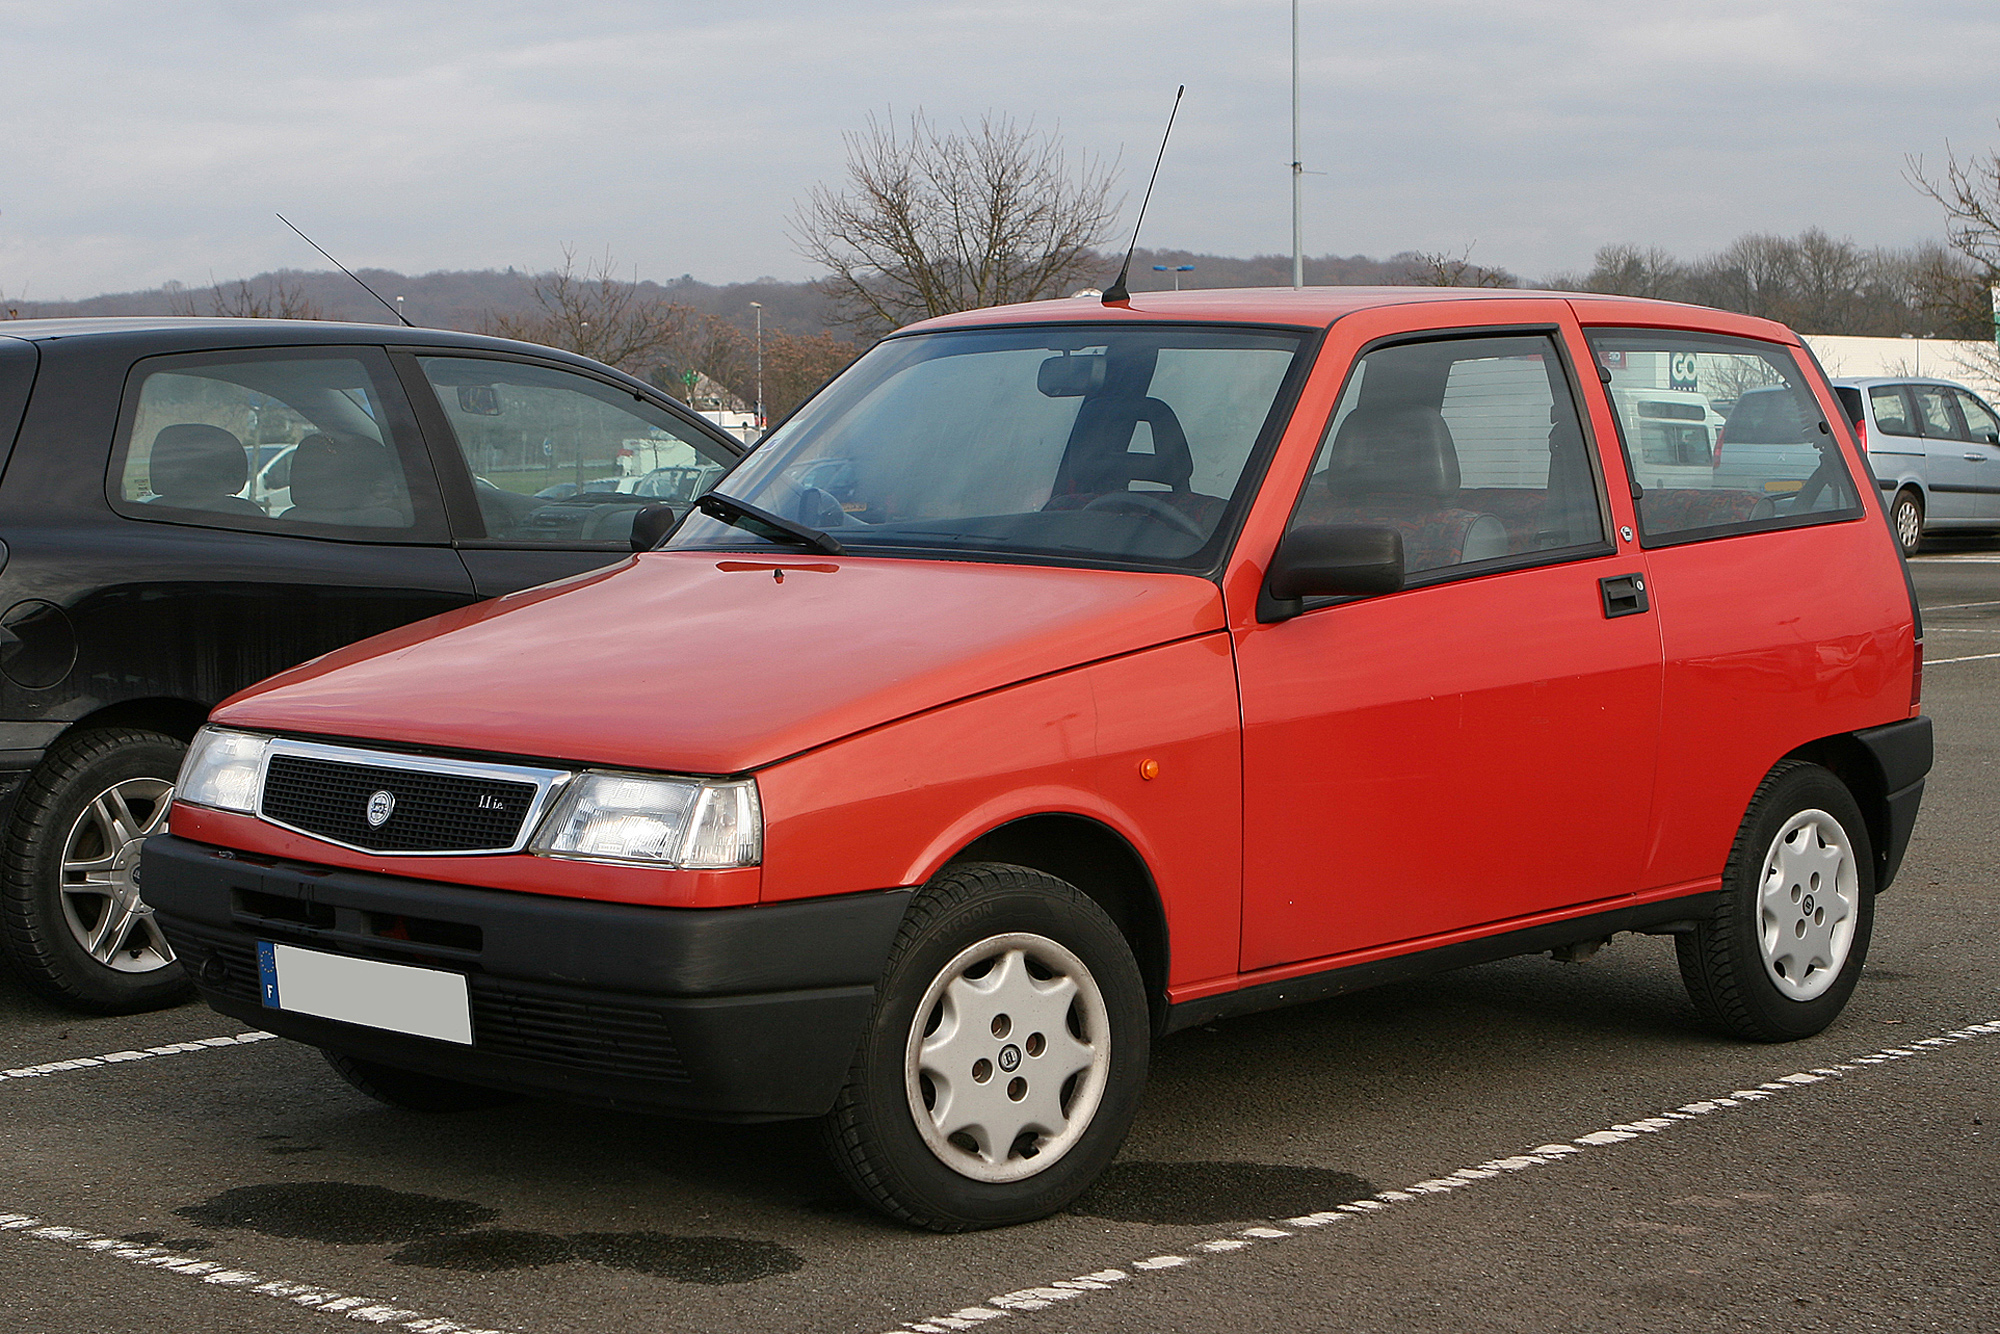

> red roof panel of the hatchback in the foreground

[{"left": 904, "top": 288, "right": 1792, "bottom": 342}]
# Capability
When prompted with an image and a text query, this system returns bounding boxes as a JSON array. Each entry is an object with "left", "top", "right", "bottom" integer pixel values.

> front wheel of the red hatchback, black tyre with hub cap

[{"left": 822, "top": 862, "right": 1150, "bottom": 1232}]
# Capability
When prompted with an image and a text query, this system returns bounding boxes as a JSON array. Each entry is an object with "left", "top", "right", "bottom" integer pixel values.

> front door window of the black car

[{"left": 418, "top": 356, "right": 736, "bottom": 546}]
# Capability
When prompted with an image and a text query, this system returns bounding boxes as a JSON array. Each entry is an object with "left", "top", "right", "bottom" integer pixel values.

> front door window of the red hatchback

[{"left": 1292, "top": 334, "right": 1606, "bottom": 576}]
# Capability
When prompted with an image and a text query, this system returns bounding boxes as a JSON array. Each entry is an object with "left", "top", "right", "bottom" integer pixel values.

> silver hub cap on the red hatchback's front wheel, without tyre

[{"left": 904, "top": 932, "right": 1110, "bottom": 1182}]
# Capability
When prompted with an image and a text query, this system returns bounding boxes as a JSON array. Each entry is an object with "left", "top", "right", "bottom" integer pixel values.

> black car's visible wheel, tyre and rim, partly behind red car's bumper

[{"left": 0, "top": 728, "right": 194, "bottom": 1014}]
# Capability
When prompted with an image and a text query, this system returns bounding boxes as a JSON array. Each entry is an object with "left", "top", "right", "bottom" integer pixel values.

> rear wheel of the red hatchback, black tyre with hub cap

[{"left": 1676, "top": 760, "right": 1874, "bottom": 1042}]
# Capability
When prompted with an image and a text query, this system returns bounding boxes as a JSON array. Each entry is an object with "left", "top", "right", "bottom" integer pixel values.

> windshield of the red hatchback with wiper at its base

[{"left": 668, "top": 326, "right": 1304, "bottom": 566}]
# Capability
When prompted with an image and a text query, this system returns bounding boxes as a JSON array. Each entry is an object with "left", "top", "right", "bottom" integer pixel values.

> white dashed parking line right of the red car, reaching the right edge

[{"left": 886, "top": 1020, "right": 2000, "bottom": 1334}]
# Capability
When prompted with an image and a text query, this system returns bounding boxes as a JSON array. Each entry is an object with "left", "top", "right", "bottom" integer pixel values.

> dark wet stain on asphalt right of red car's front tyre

[{"left": 1070, "top": 1162, "right": 1376, "bottom": 1226}]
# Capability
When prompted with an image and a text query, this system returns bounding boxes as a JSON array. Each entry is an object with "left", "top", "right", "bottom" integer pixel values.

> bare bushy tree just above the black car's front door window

[{"left": 480, "top": 246, "right": 694, "bottom": 376}]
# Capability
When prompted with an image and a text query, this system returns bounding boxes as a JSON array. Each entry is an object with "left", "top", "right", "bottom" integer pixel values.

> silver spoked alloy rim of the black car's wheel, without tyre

[{"left": 62, "top": 778, "right": 174, "bottom": 972}]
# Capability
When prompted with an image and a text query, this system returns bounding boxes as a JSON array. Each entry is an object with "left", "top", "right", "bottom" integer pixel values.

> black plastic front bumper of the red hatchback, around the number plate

[{"left": 142, "top": 834, "right": 910, "bottom": 1118}]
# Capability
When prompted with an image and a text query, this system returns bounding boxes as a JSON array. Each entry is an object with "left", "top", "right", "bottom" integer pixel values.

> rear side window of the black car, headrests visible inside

[{"left": 110, "top": 348, "right": 442, "bottom": 542}]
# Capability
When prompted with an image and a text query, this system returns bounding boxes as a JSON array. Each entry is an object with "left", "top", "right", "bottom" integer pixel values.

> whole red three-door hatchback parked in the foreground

[{"left": 144, "top": 288, "right": 1930, "bottom": 1230}]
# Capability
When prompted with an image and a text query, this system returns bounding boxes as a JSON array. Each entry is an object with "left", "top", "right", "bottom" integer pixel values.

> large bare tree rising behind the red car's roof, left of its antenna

[{"left": 790, "top": 110, "right": 1118, "bottom": 334}]
